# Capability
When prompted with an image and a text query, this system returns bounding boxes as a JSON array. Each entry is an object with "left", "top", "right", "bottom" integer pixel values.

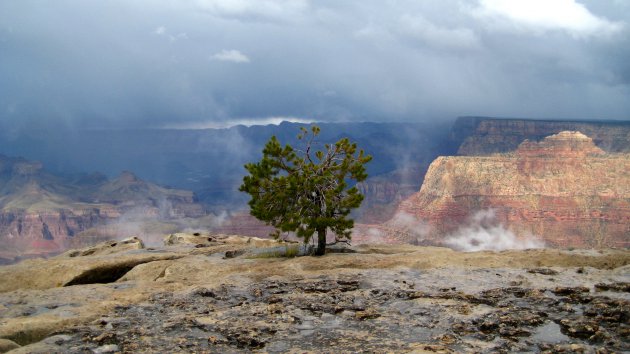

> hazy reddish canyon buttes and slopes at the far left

[{"left": 0, "top": 155, "right": 204, "bottom": 260}]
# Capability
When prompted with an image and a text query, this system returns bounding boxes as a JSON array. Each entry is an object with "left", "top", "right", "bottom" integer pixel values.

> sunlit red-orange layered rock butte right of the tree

[{"left": 390, "top": 132, "right": 630, "bottom": 248}]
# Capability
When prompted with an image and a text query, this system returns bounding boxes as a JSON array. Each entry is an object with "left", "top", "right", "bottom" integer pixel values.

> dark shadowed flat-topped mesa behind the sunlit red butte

[{"left": 451, "top": 117, "right": 630, "bottom": 156}]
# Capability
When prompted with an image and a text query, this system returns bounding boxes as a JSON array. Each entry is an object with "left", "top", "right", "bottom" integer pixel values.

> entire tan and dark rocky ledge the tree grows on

[{"left": 0, "top": 234, "right": 630, "bottom": 353}]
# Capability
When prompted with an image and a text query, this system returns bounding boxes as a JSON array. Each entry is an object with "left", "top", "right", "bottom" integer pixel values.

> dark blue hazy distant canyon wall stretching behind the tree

[{"left": 0, "top": 121, "right": 457, "bottom": 212}]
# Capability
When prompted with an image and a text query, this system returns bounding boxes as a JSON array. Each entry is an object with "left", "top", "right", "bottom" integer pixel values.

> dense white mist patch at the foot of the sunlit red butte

[{"left": 444, "top": 209, "right": 545, "bottom": 252}]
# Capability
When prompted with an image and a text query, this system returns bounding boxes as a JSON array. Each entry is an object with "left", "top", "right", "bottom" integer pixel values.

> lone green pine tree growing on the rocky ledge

[{"left": 239, "top": 125, "right": 372, "bottom": 255}]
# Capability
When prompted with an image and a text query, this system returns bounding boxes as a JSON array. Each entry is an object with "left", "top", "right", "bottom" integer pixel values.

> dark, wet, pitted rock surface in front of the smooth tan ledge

[{"left": 16, "top": 268, "right": 630, "bottom": 353}]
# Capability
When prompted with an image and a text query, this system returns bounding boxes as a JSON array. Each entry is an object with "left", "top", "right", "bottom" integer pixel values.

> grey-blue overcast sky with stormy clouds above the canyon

[{"left": 0, "top": 0, "right": 630, "bottom": 128}]
